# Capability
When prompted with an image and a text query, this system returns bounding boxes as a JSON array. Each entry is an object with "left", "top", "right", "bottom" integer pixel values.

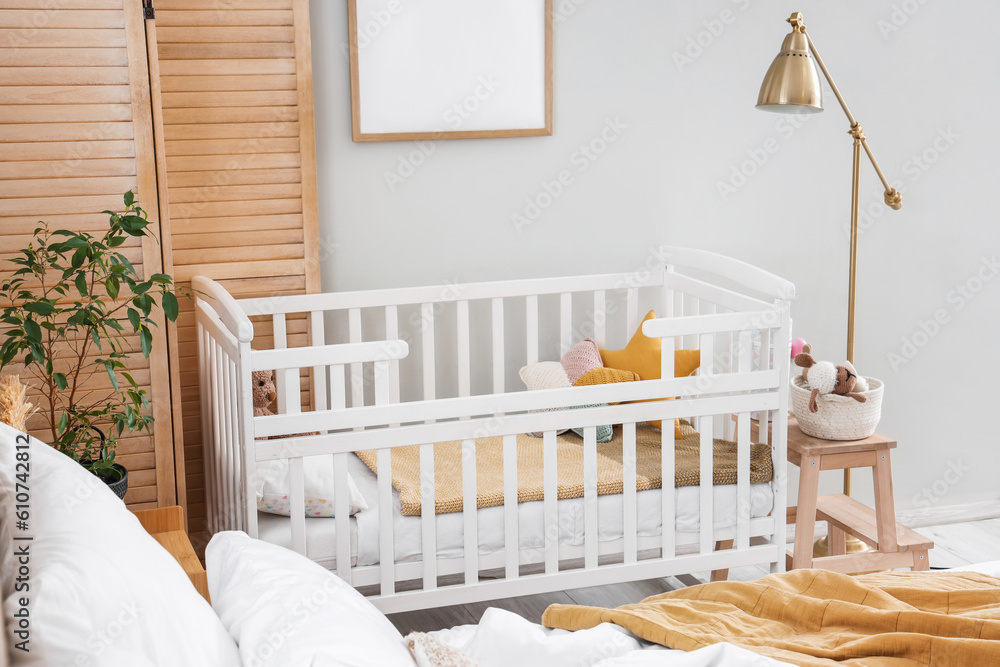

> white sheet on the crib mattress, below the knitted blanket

[{"left": 258, "top": 456, "right": 774, "bottom": 566}]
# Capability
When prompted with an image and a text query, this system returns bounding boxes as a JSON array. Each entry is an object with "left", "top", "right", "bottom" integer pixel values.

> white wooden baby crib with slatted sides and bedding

[{"left": 193, "top": 247, "right": 794, "bottom": 613}]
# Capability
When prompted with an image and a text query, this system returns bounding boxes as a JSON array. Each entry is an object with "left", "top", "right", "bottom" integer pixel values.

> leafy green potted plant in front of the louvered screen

[{"left": 0, "top": 191, "right": 189, "bottom": 498}]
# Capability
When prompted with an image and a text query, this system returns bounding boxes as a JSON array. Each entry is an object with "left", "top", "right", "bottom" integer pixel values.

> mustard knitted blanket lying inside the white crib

[{"left": 358, "top": 421, "right": 773, "bottom": 516}]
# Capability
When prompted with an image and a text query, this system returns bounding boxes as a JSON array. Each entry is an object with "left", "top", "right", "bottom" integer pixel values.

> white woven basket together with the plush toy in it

[{"left": 791, "top": 353, "right": 883, "bottom": 440}]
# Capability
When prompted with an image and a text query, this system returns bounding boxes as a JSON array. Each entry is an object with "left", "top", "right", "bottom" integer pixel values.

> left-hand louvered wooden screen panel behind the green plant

[{"left": 0, "top": 0, "right": 177, "bottom": 509}]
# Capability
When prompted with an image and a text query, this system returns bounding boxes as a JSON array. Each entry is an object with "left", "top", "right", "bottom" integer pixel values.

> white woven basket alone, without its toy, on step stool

[{"left": 791, "top": 375, "right": 884, "bottom": 440}]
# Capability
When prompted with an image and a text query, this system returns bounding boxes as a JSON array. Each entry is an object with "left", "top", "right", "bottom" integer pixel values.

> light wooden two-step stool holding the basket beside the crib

[{"left": 787, "top": 419, "right": 934, "bottom": 574}]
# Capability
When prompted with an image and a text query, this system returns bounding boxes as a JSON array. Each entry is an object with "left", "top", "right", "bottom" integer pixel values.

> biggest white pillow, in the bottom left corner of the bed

[{"left": 0, "top": 424, "right": 240, "bottom": 667}]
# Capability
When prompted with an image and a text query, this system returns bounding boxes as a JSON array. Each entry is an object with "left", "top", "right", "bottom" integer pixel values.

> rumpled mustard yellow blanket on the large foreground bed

[{"left": 542, "top": 570, "right": 1000, "bottom": 667}]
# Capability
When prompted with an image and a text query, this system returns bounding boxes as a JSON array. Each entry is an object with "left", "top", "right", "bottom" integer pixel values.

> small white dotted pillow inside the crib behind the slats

[{"left": 257, "top": 454, "right": 368, "bottom": 517}]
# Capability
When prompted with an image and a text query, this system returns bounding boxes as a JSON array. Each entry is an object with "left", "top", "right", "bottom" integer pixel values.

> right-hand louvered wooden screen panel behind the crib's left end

[{"left": 149, "top": 0, "right": 320, "bottom": 532}]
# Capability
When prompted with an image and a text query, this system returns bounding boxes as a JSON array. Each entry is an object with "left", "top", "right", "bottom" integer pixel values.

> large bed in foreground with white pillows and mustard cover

[{"left": 0, "top": 424, "right": 1000, "bottom": 667}]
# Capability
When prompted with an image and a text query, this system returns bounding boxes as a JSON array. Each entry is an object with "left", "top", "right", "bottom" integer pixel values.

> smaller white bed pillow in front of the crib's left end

[{"left": 209, "top": 531, "right": 415, "bottom": 667}]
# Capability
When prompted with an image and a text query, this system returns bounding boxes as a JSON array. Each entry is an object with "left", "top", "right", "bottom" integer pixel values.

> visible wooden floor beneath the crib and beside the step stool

[{"left": 389, "top": 517, "right": 1000, "bottom": 635}]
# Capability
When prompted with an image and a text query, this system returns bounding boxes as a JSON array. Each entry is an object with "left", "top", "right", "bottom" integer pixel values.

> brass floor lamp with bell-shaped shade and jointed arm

[{"left": 757, "top": 12, "right": 902, "bottom": 555}]
